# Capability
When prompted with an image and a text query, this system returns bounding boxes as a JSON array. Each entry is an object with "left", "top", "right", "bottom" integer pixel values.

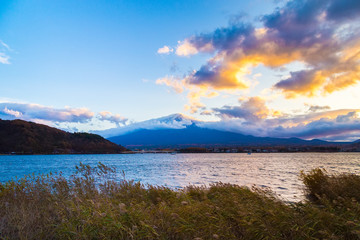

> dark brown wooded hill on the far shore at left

[{"left": 0, "top": 120, "right": 126, "bottom": 154}]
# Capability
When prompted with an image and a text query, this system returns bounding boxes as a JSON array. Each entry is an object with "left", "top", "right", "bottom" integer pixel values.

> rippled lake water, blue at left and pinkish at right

[{"left": 0, "top": 153, "right": 360, "bottom": 201}]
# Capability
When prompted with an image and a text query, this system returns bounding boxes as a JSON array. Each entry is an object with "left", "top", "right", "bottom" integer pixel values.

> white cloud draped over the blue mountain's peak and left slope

[{"left": 93, "top": 113, "right": 201, "bottom": 138}]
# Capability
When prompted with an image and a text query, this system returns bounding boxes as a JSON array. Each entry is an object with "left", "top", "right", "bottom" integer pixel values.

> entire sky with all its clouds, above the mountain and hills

[{"left": 0, "top": 0, "right": 360, "bottom": 141}]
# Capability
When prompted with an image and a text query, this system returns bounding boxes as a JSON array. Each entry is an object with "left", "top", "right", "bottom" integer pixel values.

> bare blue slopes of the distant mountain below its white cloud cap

[{"left": 108, "top": 123, "right": 332, "bottom": 148}]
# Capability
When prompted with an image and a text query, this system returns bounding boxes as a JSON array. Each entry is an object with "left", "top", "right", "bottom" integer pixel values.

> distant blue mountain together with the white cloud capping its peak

[{"left": 103, "top": 114, "right": 344, "bottom": 148}]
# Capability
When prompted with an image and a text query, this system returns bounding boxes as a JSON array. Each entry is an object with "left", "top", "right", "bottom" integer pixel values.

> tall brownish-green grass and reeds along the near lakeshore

[{"left": 0, "top": 163, "right": 360, "bottom": 240}]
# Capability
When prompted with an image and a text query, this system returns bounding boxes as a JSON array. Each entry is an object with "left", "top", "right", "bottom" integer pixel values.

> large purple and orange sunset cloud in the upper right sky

[{"left": 162, "top": 0, "right": 360, "bottom": 98}]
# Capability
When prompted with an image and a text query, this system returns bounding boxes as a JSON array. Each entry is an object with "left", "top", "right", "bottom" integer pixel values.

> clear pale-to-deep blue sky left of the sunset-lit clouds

[{"left": 0, "top": 1, "right": 272, "bottom": 120}]
